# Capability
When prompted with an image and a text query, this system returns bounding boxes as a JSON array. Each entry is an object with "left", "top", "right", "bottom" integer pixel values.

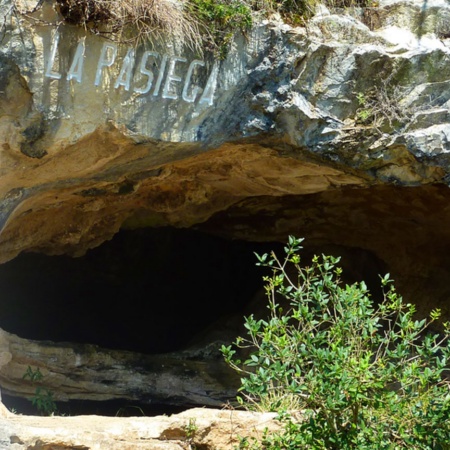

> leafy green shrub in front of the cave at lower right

[{"left": 222, "top": 237, "right": 450, "bottom": 450}]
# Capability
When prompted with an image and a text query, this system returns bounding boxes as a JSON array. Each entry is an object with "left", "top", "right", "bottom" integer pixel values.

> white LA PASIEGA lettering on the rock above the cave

[{"left": 45, "top": 33, "right": 218, "bottom": 106}]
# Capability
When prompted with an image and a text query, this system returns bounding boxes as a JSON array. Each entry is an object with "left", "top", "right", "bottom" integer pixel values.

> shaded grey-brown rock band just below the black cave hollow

[{"left": 0, "top": 330, "right": 239, "bottom": 407}]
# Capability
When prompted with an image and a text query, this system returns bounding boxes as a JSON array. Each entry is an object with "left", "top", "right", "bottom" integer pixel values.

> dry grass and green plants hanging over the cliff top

[{"left": 52, "top": 0, "right": 374, "bottom": 57}]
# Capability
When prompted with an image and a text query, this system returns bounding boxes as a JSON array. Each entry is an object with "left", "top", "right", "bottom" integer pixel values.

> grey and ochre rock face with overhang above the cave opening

[{"left": 0, "top": 0, "right": 450, "bottom": 432}]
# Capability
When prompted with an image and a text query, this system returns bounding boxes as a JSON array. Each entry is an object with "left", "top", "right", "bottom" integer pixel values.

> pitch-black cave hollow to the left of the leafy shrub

[{"left": 0, "top": 228, "right": 382, "bottom": 416}]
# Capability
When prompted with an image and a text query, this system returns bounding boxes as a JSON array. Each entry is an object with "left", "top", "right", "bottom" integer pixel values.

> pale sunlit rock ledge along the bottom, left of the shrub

[{"left": 0, "top": 404, "right": 278, "bottom": 450}]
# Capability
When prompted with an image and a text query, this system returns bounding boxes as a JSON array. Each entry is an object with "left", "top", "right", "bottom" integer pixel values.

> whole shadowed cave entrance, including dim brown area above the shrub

[{"left": 4, "top": 186, "right": 450, "bottom": 415}]
